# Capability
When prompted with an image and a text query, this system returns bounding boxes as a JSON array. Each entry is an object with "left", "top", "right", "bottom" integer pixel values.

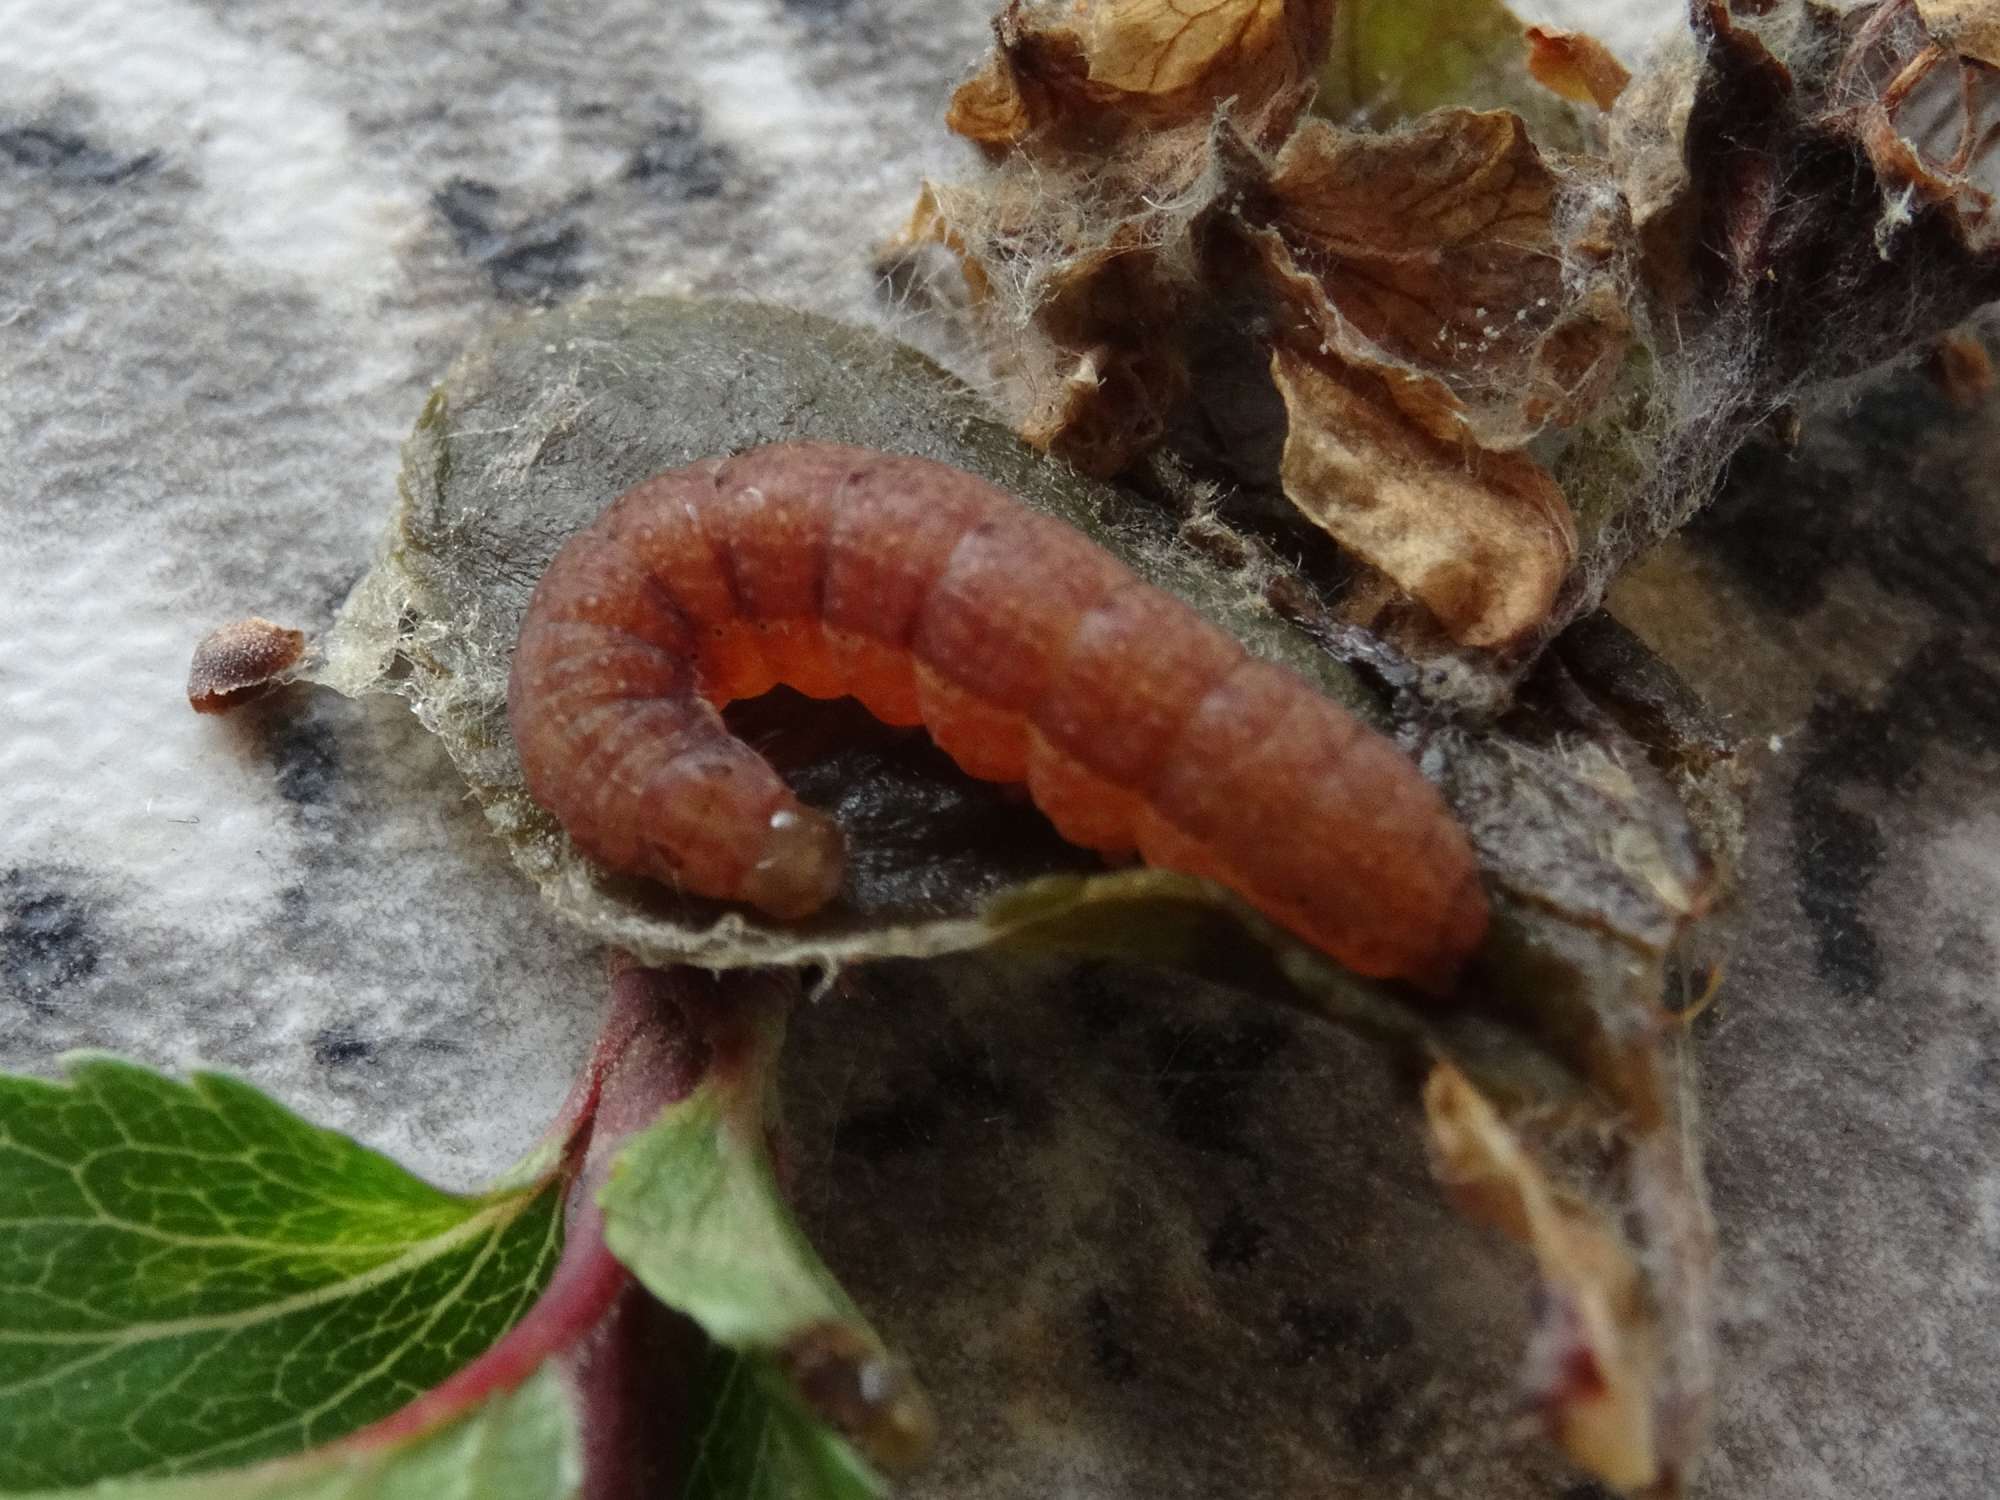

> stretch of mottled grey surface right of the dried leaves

[{"left": 1616, "top": 376, "right": 2000, "bottom": 1496}]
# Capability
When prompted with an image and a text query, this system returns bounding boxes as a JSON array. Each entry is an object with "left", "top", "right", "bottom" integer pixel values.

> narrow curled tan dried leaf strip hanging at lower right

[{"left": 1424, "top": 1062, "right": 1662, "bottom": 1490}]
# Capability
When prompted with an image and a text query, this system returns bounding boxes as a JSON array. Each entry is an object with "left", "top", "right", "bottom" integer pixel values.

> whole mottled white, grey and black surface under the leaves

[{"left": 0, "top": 0, "right": 2000, "bottom": 1500}]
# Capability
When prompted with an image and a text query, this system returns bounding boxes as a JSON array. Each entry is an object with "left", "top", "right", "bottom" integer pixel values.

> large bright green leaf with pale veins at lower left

[{"left": 0, "top": 1056, "right": 562, "bottom": 1494}]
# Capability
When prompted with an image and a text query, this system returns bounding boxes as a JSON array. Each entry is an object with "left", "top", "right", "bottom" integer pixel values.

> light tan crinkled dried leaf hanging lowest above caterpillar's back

[{"left": 1272, "top": 346, "right": 1576, "bottom": 646}]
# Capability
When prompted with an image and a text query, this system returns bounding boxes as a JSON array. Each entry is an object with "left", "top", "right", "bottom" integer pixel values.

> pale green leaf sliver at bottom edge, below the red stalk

[{"left": 7, "top": 1370, "right": 582, "bottom": 1500}]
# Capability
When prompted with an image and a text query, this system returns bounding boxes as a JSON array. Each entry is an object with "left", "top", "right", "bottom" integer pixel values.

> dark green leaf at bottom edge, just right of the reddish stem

[{"left": 680, "top": 1348, "right": 884, "bottom": 1500}]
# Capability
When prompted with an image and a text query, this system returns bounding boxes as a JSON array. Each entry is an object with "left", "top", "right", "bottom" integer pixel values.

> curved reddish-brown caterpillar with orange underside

[{"left": 508, "top": 442, "right": 1486, "bottom": 986}]
